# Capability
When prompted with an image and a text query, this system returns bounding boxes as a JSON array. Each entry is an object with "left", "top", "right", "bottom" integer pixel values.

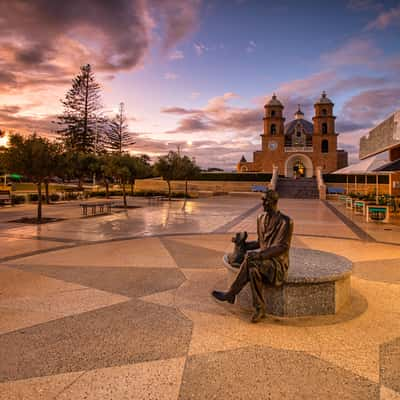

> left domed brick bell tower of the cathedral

[{"left": 261, "top": 93, "right": 285, "bottom": 150}]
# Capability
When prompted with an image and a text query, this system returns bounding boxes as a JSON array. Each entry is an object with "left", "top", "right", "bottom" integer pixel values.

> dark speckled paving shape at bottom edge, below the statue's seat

[{"left": 179, "top": 346, "right": 379, "bottom": 400}]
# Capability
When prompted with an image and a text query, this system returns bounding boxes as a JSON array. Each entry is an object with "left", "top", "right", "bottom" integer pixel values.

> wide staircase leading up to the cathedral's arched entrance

[{"left": 276, "top": 178, "right": 319, "bottom": 199}]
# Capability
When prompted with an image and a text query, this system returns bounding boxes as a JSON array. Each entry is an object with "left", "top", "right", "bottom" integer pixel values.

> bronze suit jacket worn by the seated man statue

[{"left": 257, "top": 211, "right": 293, "bottom": 286}]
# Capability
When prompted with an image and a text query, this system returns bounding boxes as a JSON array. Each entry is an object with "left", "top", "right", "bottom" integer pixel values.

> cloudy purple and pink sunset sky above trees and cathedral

[{"left": 0, "top": 0, "right": 400, "bottom": 170}]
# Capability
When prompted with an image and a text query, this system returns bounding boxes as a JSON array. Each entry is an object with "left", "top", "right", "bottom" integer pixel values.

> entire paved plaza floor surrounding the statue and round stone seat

[{"left": 0, "top": 194, "right": 400, "bottom": 400}]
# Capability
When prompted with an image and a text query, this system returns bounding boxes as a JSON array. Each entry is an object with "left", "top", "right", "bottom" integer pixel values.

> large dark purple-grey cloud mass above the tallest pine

[{"left": 0, "top": 0, "right": 200, "bottom": 87}]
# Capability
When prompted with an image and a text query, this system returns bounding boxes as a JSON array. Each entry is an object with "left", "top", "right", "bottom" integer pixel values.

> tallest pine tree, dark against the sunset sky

[{"left": 57, "top": 64, "right": 105, "bottom": 153}]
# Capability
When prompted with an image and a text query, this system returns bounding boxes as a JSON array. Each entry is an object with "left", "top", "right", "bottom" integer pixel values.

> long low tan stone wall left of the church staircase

[{"left": 135, "top": 179, "right": 269, "bottom": 193}]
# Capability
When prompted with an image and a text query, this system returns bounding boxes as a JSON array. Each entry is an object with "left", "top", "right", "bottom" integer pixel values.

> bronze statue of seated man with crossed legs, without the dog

[{"left": 212, "top": 190, "right": 293, "bottom": 322}]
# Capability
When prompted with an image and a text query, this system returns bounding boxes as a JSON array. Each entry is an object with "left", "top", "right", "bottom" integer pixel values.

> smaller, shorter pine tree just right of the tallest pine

[{"left": 106, "top": 103, "right": 136, "bottom": 154}]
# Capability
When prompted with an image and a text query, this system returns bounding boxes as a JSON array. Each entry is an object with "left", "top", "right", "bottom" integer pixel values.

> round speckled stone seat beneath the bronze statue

[{"left": 223, "top": 248, "right": 352, "bottom": 317}]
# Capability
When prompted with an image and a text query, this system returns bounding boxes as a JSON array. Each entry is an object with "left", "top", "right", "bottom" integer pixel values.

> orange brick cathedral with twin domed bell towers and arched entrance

[{"left": 237, "top": 92, "right": 347, "bottom": 178}]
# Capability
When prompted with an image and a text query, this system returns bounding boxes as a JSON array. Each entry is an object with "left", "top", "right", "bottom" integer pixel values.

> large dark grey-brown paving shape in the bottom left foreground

[{"left": 0, "top": 300, "right": 192, "bottom": 382}]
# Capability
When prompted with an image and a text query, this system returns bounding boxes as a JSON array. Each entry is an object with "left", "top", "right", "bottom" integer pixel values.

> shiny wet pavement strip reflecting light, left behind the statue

[{"left": 0, "top": 195, "right": 260, "bottom": 241}]
